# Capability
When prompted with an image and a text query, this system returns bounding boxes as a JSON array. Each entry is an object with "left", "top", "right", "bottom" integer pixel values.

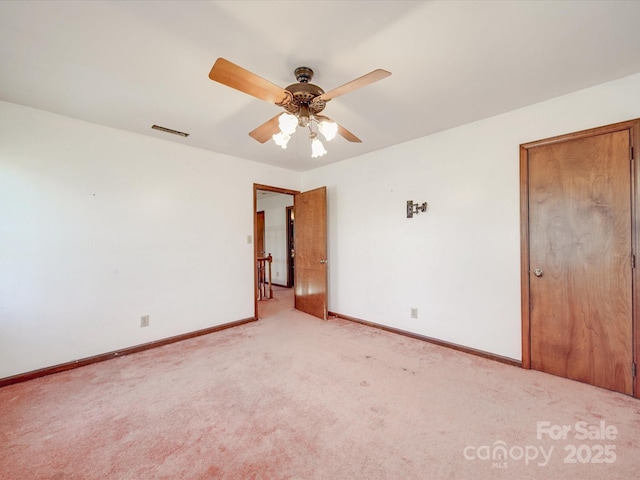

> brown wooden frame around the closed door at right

[{"left": 520, "top": 119, "right": 640, "bottom": 398}]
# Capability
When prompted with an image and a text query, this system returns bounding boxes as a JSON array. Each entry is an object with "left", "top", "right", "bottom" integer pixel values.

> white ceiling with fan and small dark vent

[{"left": 0, "top": 0, "right": 640, "bottom": 171}]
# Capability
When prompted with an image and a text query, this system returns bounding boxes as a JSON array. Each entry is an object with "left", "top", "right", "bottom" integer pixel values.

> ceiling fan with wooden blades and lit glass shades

[{"left": 209, "top": 58, "right": 391, "bottom": 157}]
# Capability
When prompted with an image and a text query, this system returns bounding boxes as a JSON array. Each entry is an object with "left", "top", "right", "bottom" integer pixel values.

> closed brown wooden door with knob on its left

[{"left": 522, "top": 122, "right": 634, "bottom": 395}]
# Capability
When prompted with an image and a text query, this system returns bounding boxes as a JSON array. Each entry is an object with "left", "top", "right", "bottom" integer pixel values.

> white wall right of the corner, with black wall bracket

[{"left": 303, "top": 75, "right": 640, "bottom": 360}]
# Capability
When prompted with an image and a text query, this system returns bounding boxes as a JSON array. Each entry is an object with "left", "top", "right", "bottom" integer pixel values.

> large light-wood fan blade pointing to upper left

[{"left": 209, "top": 58, "right": 292, "bottom": 106}]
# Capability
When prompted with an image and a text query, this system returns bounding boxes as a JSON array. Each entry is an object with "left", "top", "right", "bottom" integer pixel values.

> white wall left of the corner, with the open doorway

[{"left": 0, "top": 102, "right": 300, "bottom": 378}]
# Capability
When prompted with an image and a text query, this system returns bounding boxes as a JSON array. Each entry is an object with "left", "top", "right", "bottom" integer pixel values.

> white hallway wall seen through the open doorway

[{"left": 257, "top": 194, "right": 293, "bottom": 286}]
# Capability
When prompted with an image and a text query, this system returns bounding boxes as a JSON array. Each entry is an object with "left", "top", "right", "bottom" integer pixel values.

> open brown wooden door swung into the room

[{"left": 293, "top": 187, "right": 327, "bottom": 319}]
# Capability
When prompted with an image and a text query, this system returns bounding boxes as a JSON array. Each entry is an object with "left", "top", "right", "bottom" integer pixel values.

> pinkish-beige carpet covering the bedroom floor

[{"left": 0, "top": 289, "right": 640, "bottom": 480}]
